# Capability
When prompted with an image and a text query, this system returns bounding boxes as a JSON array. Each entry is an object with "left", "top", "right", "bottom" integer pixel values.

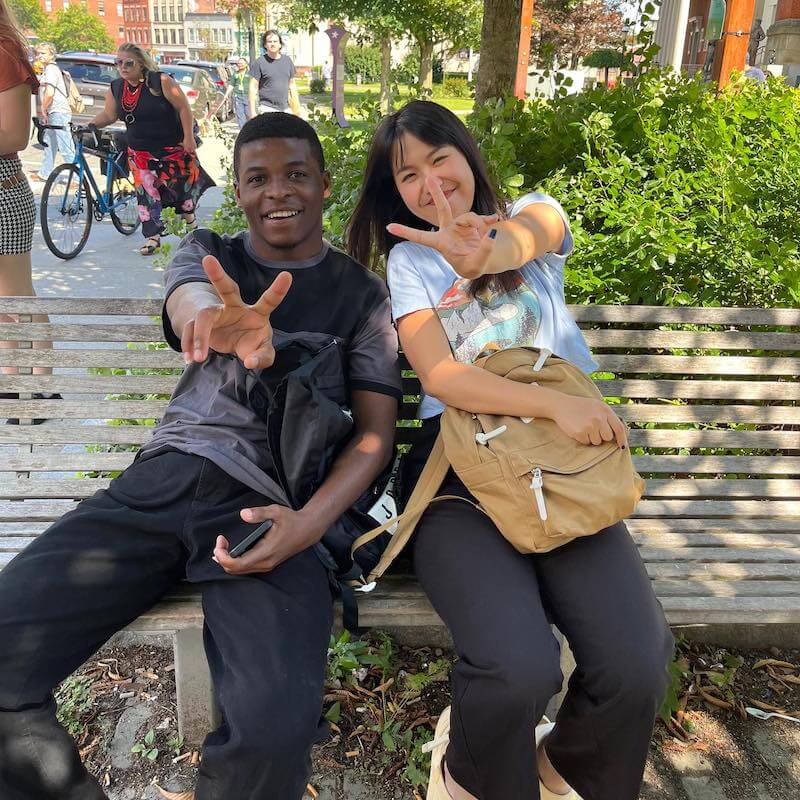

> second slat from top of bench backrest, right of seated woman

[{"left": 583, "top": 328, "right": 800, "bottom": 352}]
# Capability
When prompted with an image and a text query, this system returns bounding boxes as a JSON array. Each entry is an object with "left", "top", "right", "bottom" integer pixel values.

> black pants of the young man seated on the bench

[{"left": 0, "top": 452, "right": 332, "bottom": 800}]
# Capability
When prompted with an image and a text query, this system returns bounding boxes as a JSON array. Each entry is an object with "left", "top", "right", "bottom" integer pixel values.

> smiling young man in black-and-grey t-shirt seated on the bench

[{"left": 0, "top": 114, "right": 400, "bottom": 800}]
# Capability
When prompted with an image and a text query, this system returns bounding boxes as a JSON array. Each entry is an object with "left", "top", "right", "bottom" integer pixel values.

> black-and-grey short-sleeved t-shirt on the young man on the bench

[{"left": 142, "top": 230, "right": 402, "bottom": 497}]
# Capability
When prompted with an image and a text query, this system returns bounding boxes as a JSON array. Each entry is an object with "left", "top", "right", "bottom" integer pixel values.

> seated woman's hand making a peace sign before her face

[{"left": 386, "top": 176, "right": 500, "bottom": 278}]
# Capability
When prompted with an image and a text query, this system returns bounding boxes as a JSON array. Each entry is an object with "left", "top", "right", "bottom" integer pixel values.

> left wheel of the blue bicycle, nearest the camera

[{"left": 39, "top": 164, "right": 92, "bottom": 260}]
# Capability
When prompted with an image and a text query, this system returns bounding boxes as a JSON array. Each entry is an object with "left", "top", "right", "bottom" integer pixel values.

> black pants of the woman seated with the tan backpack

[{"left": 413, "top": 474, "right": 673, "bottom": 800}]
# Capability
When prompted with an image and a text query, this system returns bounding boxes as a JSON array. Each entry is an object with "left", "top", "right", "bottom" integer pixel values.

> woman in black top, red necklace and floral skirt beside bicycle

[{"left": 89, "top": 42, "right": 214, "bottom": 256}]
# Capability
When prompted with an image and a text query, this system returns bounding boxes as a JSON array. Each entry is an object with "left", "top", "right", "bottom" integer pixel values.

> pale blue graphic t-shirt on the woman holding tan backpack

[{"left": 386, "top": 192, "right": 598, "bottom": 419}]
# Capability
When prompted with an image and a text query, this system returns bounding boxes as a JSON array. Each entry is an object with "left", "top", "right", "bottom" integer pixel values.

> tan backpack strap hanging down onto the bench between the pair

[{"left": 350, "top": 433, "right": 480, "bottom": 583}]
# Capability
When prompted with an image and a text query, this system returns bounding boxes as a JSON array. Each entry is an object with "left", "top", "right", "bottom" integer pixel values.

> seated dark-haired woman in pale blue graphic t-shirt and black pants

[{"left": 348, "top": 101, "right": 672, "bottom": 800}]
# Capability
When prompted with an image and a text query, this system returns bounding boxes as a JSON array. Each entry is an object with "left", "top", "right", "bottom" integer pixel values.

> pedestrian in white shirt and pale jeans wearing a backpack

[{"left": 31, "top": 42, "right": 75, "bottom": 183}]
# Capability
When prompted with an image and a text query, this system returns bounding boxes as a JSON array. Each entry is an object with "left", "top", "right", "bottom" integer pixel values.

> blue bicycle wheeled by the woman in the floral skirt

[{"left": 33, "top": 118, "right": 140, "bottom": 260}]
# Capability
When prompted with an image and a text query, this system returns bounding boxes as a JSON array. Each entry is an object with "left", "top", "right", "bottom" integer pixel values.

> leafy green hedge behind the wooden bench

[{"left": 215, "top": 71, "right": 800, "bottom": 307}]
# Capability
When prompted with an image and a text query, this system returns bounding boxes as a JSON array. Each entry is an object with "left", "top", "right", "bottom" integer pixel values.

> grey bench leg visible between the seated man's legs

[{"left": 173, "top": 628, "right": 220, "bottom": 747}]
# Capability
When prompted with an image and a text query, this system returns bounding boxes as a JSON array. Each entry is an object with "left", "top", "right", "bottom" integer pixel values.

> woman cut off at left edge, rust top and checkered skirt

[{"left": 0, "top": 0, "right": 60, "bottom": 422}]
